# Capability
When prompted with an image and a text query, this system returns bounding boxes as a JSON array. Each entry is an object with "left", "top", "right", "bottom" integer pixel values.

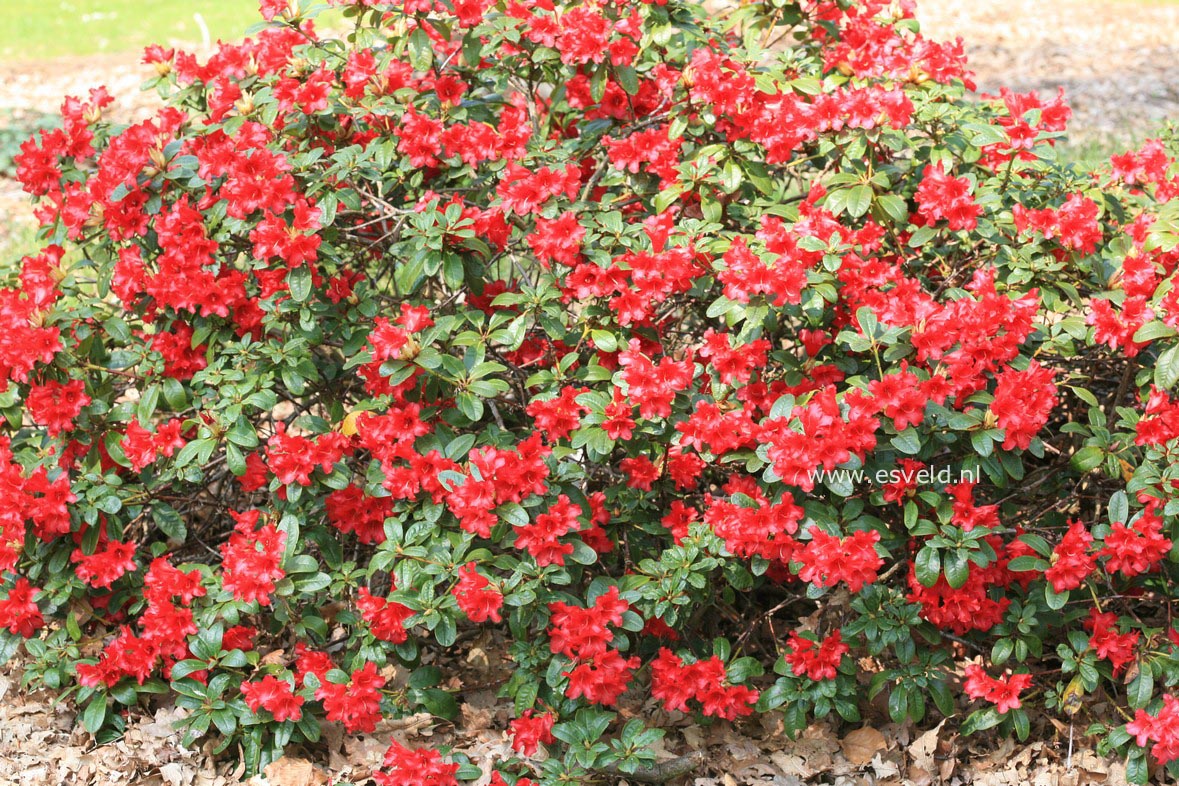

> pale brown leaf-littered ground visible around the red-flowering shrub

[{"left": 0, "top": 0, "right": 1179, "bottom": 786}]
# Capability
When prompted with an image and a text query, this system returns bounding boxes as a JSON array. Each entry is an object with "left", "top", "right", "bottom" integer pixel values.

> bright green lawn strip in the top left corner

[{"left": 0, "top": 0, "right": 262, "bottom": 62}]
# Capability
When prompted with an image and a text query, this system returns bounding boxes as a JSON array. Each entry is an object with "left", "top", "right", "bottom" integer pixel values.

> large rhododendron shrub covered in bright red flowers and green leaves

[{"left": 0, "top": 0, "right": 1179, "bottom": 784}]
